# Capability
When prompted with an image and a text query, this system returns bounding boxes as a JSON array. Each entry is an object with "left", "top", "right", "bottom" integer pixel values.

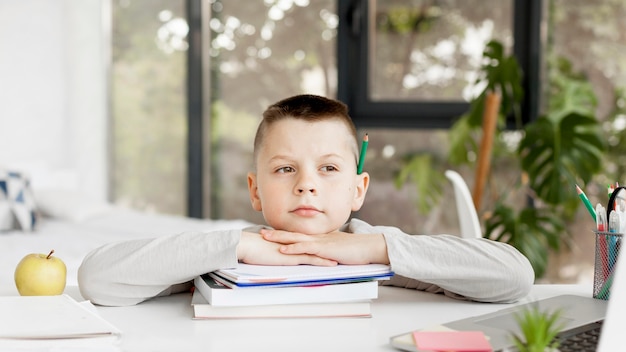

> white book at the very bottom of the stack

[{"left": 191, "top": 290, "right": 372, "bottom": 319}]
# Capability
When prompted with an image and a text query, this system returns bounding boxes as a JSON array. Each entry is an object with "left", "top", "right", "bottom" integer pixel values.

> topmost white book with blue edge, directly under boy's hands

[{"left": 214, "top": 263, "right": 393, "bottom": 286}]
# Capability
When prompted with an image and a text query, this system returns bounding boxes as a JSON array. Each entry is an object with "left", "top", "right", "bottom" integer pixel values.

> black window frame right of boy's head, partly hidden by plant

[{"left": 337, "top": 0, "right": 541, "bottom": 129}]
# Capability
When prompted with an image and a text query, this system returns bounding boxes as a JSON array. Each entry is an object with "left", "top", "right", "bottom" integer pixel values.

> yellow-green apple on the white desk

[{"left": 15, "top": 249, "right": 67, "bottom": 296}]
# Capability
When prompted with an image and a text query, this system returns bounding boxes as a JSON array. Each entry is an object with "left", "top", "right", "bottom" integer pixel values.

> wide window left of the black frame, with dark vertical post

[{"left": 111, "top": 0, "right": 338, "bottom": 217}]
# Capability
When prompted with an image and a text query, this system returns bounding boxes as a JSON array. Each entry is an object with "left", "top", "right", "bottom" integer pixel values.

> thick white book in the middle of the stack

[{"left": 195, "top": 274, "right": 378, "bottom": 306}]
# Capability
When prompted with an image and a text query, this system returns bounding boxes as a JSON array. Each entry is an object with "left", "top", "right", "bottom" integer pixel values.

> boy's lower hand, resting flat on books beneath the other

[{"left": 237, "top": 231, "right": 337, "bottom": 266}]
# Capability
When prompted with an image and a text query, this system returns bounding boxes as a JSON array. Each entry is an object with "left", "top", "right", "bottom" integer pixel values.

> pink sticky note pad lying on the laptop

[{"left": 413, "top": 331, "right": 492, "bottom": 352}]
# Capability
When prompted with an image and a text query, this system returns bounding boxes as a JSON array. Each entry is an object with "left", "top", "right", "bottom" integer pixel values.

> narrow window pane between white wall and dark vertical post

[{"left": 111, "top": 0, "right": 188, "bottom": 215}]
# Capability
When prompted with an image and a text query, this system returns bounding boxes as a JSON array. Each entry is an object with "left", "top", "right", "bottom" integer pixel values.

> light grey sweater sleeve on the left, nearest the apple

[{"left": 78, "top": 230, "right": 241, "bottom": 306}]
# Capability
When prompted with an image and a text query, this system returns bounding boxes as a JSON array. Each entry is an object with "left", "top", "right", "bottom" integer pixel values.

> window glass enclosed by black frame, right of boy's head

[{"left": 368, "top": 0, "right": 513, "bottom": 102}]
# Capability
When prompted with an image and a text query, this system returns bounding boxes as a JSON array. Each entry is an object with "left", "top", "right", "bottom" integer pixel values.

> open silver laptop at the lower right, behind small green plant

[{"left": 390, "top": 260, "right": 626, "bottom": 351}]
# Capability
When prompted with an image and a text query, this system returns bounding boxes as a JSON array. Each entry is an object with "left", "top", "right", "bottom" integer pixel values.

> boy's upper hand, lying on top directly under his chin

[{"left": 261, "top": 229, "right": 389, "bottom": 264}]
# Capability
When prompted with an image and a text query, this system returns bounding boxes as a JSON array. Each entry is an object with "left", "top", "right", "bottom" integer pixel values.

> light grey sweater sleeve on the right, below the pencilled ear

[{"left": 350, "top": 220, "right": 535, "bottom": 302}]
